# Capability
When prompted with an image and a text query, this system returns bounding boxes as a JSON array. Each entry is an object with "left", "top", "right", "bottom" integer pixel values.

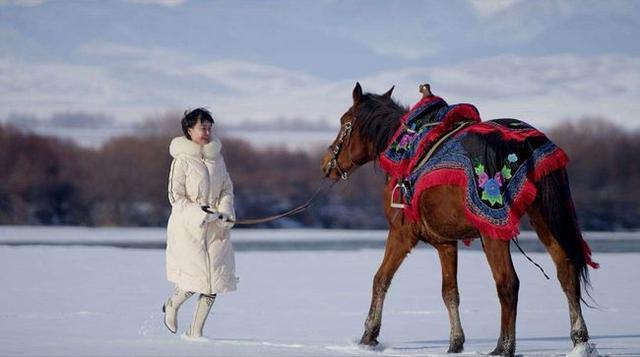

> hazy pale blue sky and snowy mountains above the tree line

[{"left": 0, "top": 0, "right": 640, "bottom": 128}]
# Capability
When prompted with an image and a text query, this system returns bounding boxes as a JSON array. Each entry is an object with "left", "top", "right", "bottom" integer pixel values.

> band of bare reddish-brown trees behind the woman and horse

[{"left": 0, "top": 115, "right": 640, "bottom": 230}]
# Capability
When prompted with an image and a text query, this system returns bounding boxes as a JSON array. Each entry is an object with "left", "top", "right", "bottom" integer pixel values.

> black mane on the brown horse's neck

[{"left": 354, "top": 93, "right": 409, "bottom": 156}]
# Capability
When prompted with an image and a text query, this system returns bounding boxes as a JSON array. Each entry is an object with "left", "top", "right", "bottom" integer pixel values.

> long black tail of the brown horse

[{"left": 537, "top": 168, "right": 598, "bottom": 303}]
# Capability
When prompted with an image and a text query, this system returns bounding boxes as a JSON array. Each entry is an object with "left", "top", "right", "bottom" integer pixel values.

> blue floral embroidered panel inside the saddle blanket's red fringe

[{"left": 404, "top": 119, "right": 559, "bottom": 225}]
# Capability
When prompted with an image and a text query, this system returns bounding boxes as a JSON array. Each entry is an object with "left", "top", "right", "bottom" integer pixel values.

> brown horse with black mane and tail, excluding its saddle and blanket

[{"left": 322, "top": 83, "right": 589, "bottom": 356}]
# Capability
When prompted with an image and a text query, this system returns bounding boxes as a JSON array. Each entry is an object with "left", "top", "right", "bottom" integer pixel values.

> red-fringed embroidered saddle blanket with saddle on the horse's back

[{"left": 379, "top": 96, "right": 568, "bottom": 240}]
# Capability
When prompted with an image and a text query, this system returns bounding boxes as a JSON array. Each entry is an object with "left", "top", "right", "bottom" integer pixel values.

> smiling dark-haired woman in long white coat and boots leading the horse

[{"left": 162, "top": 108, "right": 238, "bottom": 337}]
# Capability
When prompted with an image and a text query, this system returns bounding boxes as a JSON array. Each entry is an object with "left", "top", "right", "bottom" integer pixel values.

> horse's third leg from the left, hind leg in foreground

[{"left": 483, "top": 237, "right": 520, "bottom": 356}]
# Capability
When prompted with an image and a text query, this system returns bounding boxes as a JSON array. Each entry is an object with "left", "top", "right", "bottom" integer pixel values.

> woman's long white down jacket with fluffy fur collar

[{"left": 166, "top": 136, "right": 238, "bottom": 294}]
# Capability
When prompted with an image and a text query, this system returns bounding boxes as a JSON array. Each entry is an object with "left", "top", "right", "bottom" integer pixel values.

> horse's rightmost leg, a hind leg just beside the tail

[{"left": 527, "top": 205, "right": 589, "bottom": 346}]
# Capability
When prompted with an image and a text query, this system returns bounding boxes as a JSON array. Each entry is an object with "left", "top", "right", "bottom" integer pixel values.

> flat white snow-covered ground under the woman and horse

[{"left": 0, "top": 228, "right": 640, "bottom": 356}]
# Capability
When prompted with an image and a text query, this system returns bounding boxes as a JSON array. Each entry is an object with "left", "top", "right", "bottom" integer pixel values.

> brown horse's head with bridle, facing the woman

[{"left": 322, "top": 83, "right": 406, "bottom": 180}]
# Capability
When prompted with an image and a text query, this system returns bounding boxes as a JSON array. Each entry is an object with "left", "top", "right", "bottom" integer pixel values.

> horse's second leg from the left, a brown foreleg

[{"left": 435, "top": 242, "right": 464, "bottom": 353}]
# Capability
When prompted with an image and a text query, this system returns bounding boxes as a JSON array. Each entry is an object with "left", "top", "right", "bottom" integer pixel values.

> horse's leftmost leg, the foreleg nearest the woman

[{"left": 360, "top": 229, "right": 418, "bottom": 346}]
